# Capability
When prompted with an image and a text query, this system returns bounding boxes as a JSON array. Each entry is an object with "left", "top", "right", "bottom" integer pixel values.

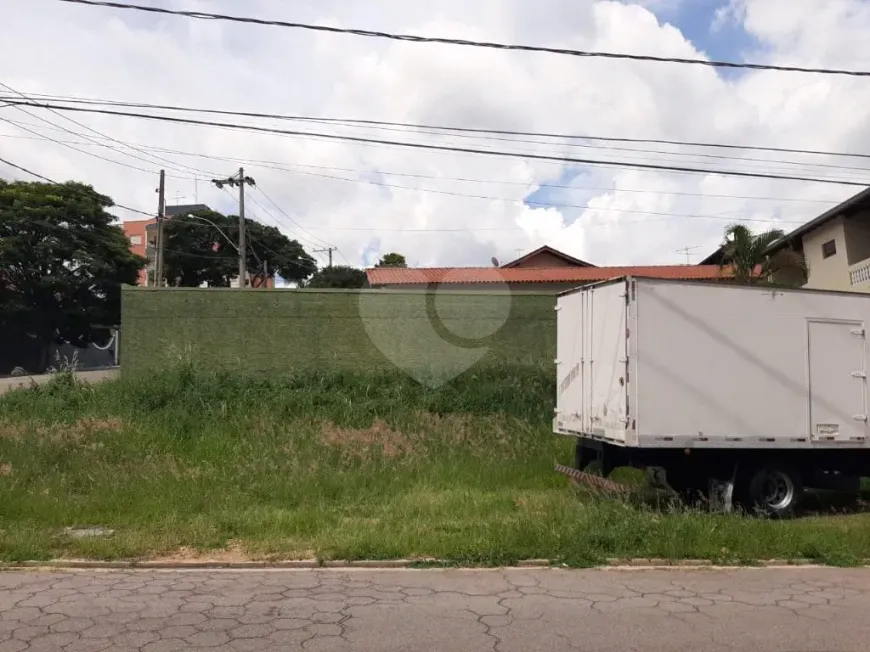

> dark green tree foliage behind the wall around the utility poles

[{"left": 163, "top": 211, "right": 317, "bottom": 287}]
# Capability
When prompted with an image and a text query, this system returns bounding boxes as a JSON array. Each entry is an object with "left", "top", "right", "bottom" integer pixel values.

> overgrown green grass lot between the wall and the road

[{"left": 0, "top": 367, "right": 870, "bottom": 565}]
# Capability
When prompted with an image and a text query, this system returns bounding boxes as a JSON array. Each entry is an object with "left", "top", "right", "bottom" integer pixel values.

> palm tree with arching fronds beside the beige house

[{"left": 720, "top": 224, "right": 807, "bottom": 287}]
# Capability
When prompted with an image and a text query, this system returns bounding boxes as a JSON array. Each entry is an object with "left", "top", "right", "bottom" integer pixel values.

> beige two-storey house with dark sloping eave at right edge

[{"left": 768, "top": 188, "right": 870, "bottom": 292}]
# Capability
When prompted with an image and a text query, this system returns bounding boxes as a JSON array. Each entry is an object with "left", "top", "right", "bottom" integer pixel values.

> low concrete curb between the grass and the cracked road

[{"left": 0, "top": 558, "right": 852, "bottom": 571}]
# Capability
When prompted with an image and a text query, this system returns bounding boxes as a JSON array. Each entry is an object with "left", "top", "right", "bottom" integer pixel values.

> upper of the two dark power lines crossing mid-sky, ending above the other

[{"left": 6, "top": 93, "right": 870, "bottom": 159}]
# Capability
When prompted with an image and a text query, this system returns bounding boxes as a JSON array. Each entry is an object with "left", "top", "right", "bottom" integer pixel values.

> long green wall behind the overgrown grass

[{"left": 120, "top": 287, "right": 556, "bottom": 378}]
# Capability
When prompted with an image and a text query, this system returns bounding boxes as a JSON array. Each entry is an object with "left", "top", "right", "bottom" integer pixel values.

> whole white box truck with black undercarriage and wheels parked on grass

[{"left": 553, "top": 277, "right": 870, "bottom": 516}]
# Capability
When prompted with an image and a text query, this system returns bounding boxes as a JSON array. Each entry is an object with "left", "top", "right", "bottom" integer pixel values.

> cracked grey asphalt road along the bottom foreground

[{"left": 0, "top": 568, "right": 870, "bottom": 652}]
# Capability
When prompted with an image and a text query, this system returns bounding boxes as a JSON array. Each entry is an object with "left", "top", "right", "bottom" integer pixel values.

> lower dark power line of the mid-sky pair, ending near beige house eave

[{"left": 6, "top": 99, "right": 870, "bottom": 187}]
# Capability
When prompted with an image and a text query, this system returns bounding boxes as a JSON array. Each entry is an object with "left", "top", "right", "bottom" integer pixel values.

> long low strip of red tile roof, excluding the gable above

[{"left": 366, "top": 265, "right": 730, "bottom": 286}]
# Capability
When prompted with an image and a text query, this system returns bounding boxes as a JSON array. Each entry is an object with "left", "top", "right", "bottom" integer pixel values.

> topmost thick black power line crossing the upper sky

[{"left": 60, "top": 0, "right": 870, "bottom": 77}]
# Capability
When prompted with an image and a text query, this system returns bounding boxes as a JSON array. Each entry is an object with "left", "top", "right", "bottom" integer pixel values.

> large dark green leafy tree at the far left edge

[{"left": 0, "top": 180, "right": 145, "bottom": 369}]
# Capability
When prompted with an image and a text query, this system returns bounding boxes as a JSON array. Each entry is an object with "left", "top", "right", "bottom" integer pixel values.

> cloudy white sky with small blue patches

[{"left": 0, "top": 0, "right": 870, "bottom": 266}]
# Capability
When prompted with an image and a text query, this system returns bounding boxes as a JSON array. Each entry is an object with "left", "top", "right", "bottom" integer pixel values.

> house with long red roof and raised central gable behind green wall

[{"left": 366, "top": 247, "right": 729, "bottom": 293}]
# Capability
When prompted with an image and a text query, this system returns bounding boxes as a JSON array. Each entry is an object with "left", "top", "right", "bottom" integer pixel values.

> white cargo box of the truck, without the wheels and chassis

[{"left": 553, "top": 278, "right": 870, "bottom": 449}]
